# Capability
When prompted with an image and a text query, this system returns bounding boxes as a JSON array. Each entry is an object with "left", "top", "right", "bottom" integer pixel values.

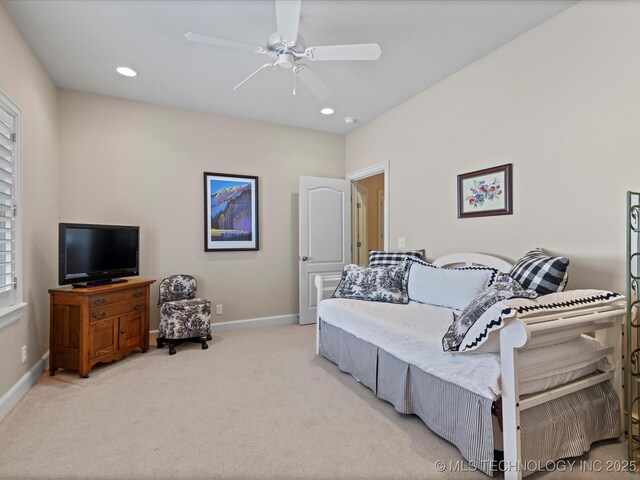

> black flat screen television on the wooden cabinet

[{"left": 58, "top": 223, "right": 140, "bottom": 287}]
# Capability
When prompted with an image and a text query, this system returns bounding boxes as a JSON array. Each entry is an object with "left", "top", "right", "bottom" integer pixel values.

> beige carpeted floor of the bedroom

[{"left": 0, "top": 326, "right": 632, "bottom": 480}]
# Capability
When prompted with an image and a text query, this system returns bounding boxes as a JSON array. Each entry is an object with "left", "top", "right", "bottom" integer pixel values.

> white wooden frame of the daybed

[{"left": 315, "top": 253, "right": 626, "bottom": 480}]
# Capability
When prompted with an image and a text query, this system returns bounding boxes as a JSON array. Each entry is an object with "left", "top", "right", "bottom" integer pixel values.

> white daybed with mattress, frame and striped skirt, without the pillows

[{"left": 315, "top": 254, "right": 625, "bottom": 479}]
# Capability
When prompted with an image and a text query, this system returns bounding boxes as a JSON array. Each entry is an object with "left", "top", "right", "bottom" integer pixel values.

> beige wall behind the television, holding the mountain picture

[{"left": 59, "top": 90, "right": 344, "bottom": 328}]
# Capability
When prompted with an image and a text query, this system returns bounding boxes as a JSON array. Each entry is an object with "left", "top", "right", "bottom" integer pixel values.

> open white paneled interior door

[{"left": 298, "top": 177, "right": 351, "bottom": 325}]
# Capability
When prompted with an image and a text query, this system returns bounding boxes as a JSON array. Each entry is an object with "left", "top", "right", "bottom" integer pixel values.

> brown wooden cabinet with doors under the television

[{"left": 49, "top": 280, "right": 155, "bottom": 378}]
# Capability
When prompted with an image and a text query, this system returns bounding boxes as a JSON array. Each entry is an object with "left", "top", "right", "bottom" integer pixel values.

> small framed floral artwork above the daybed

[{"left": 458, "top": 163, "right": 513, "bottom": 218}]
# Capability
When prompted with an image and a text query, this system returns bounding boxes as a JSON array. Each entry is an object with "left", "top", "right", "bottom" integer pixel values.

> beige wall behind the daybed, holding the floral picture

[{"left": 346, "top": 1, "right": 640, "bottom": 292}]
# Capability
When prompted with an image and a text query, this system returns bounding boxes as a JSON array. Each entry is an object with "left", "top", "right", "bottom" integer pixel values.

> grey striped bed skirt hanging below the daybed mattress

[{"left": 319, "top": 319, "right": 622, "bottom": 476}]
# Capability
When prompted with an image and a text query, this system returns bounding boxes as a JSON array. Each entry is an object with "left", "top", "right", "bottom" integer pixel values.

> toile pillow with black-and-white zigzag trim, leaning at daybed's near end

[{"left": 442, "top": 275, "right": 538, "bottom": 352}]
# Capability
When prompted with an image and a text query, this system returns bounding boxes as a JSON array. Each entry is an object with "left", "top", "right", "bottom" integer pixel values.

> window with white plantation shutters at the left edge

[{"left": 0, "top": 93, "right": 24, "bottom": 327}]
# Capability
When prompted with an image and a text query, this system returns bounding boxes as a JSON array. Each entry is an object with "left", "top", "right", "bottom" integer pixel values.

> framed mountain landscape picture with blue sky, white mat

[{"left": 204, "top": 172, "right": 259, "bottom": 252}]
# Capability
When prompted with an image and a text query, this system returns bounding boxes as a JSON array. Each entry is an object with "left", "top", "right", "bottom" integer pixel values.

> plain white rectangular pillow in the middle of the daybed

[{"left": 408, "top": 261, "right": 498, "bottom": 310}]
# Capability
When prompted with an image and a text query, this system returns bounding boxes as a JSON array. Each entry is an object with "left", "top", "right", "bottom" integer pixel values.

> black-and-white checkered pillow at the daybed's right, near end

[{"left": 509, "top": 248, "right": 569, "bottom": 295}]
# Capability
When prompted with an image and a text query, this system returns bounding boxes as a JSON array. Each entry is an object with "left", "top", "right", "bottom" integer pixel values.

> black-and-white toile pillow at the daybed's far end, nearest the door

[{"left": 332, "top": 262, "right": 409, "bottom": 303}]
